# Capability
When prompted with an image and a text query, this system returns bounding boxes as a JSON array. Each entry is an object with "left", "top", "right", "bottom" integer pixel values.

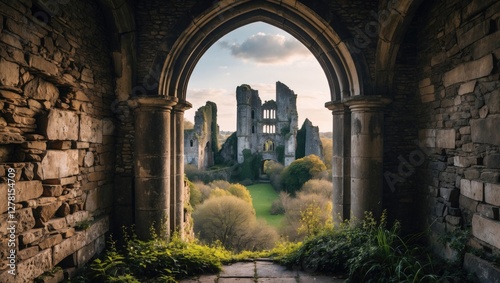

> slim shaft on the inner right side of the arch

[{"left": 325, "top": 101, "right": 351, "bottom": 225}]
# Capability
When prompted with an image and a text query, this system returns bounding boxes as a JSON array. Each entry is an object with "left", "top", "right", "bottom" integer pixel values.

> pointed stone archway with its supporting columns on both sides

[{"left": 135, "top": 0, "right": 394, "bottom": 240}]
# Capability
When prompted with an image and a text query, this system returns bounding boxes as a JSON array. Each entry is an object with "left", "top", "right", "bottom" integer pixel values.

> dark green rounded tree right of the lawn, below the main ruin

[{"left": 282, "top": 154, "right": 326, "bottom": 195}]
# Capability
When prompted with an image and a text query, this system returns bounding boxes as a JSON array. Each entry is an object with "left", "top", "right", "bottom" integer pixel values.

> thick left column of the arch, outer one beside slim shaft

[{"left": 134, "top": 96, "right": 177, "bottom": 239}]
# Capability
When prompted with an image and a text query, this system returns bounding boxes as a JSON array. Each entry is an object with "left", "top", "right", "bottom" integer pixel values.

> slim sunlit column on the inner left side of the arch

[{"left": 170, "top": 101, "right": 192, "bottom": 239}]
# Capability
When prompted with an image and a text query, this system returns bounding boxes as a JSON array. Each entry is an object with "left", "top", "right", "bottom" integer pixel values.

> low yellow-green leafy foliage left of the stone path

[{"left": 82, "top": 233, "right": 232, "bottom": 283}]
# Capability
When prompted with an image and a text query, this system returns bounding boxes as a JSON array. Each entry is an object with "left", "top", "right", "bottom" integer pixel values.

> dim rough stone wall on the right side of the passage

[{"left": 408, "top": 0, "right": 500, "bottom": 268}]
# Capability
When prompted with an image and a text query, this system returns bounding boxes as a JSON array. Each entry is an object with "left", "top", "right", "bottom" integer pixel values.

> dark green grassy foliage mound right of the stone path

[{"left": 280, "top": 214, "right": 450, "bottom": 282}]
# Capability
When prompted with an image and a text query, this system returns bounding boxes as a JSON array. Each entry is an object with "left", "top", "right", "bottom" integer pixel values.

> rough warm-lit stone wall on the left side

[{"left": 0, "top": 0, "right": 115, "bottom": 282}]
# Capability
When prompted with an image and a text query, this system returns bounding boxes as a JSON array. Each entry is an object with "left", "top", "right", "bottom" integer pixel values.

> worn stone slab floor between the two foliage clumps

[{"left": 180, "top": 260, "right": 345, "bottom": 283}]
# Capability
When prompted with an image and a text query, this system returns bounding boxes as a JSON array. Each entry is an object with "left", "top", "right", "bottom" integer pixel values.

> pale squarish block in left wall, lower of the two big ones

[{"left": 42, "top": 150, "right": 79, "bottom": 180}]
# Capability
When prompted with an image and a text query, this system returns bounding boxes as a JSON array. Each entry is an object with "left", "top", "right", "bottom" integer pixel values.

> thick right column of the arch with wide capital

[{"left": 345, "top": 96, "right": 390, "bottom": 223}]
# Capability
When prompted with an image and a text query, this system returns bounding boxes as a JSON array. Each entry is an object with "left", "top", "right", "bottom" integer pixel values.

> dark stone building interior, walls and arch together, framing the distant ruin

[{"left": 0, "top": 0, "right": 500, "bottom": 283}]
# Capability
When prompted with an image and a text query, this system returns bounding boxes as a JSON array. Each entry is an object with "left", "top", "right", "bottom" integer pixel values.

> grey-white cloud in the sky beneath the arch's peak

[{"left": 219, "top": 32, "right": 312, "bottom": 64}]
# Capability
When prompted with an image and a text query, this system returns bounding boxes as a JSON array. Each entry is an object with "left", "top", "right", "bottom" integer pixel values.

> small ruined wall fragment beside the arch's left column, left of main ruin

[{"left": 184, "top": 101, "right": 219, "bottom": 169}]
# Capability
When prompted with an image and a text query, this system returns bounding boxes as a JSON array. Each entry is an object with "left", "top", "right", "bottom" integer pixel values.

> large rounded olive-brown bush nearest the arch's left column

[{"left": 193, "top": 196, "right": 278, "bottom": 251}]
